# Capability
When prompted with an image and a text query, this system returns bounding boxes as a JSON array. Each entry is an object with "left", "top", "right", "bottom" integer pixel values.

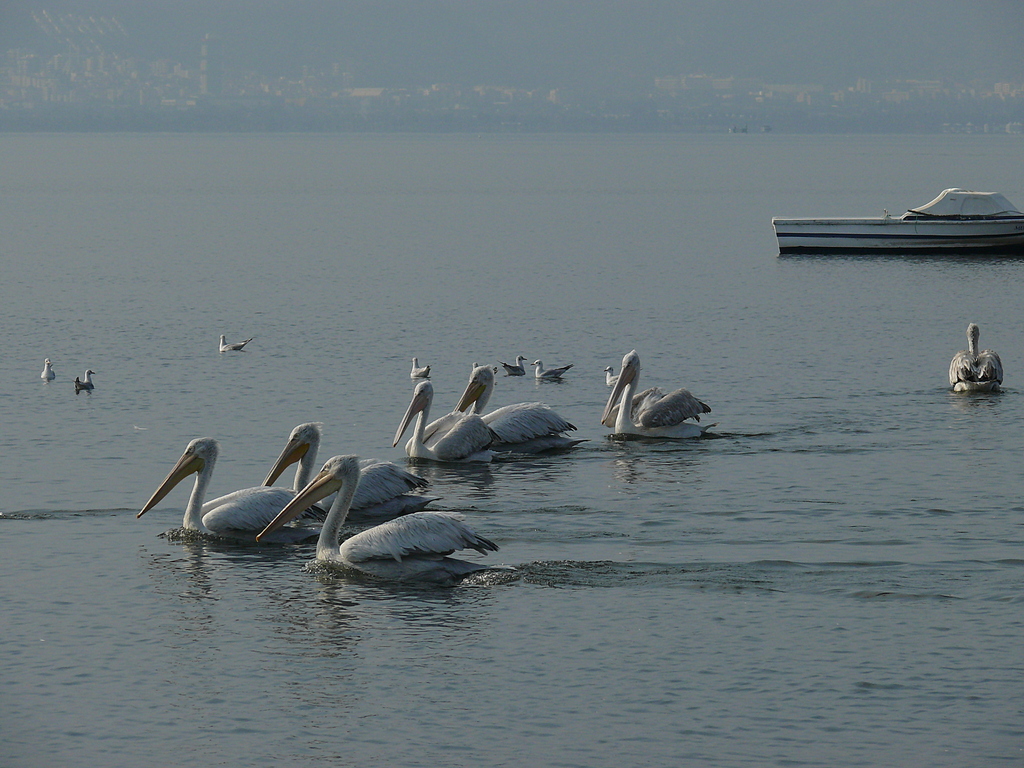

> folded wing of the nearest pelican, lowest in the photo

[{"left": 341, "top": 512, "right": 498, "bottom": 563}]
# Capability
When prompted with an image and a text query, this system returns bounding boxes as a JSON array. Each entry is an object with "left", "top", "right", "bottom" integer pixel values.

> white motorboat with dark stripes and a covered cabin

[{"left": 771, "top": 188, "right": 1024, "bottom": 253}]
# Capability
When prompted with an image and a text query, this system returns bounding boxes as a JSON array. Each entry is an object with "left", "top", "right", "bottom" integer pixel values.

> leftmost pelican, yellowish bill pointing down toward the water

[{"left": 136, "top": 437, "right": 315, "bottom": 543}]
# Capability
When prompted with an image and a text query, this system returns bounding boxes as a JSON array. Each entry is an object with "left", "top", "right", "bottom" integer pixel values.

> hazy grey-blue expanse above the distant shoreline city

[{"left": 6, "top": 0, "right": 1024, "bottom": 87}]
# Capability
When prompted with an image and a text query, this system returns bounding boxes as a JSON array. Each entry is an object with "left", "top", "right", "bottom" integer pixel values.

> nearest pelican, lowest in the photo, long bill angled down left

[{"left": 256, "top": 456, "right": 498, "bottom": 584}]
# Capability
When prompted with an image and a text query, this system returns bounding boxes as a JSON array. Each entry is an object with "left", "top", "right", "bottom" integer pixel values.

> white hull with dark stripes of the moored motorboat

[{"left": 772, "top": 216, "right": 1024, "bottom": 253}]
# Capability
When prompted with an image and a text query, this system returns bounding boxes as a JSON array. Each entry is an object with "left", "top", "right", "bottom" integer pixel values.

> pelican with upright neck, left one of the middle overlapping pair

[{"left": 391, "top": 381, "right": 495, "bottom": 462}]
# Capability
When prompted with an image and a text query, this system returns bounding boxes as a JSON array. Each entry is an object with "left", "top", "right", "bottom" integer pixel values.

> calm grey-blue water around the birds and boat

[{"left": 0, "top": 135, "right": 1024, "bottom": 768}]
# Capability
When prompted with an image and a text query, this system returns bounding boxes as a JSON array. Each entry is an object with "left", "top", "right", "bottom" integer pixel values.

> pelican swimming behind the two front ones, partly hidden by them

[{"left": 263, "top": 422, "right": 434, "bottom": 520}]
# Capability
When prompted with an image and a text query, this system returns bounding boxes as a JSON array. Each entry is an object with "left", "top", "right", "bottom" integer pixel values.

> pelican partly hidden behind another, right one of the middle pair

[{"left": 455, "top": 366, "right": 583, "bottom": 454}]
